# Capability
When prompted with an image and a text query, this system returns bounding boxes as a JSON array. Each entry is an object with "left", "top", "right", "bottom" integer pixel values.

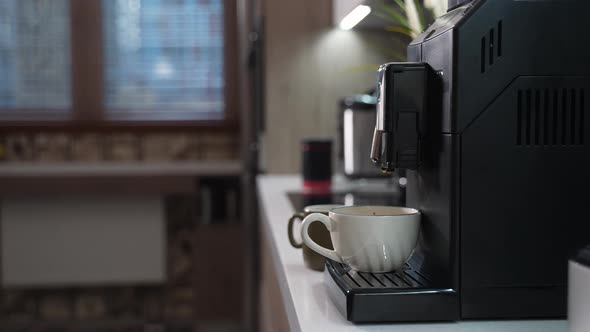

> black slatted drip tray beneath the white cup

[{"left": 324, "top": 260, "right": 459, "bottom": 323}]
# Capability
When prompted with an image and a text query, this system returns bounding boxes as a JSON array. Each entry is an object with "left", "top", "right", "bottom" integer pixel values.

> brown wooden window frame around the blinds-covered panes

[{"left": 0, "top": 0, "right": 239, "bottom": 131}]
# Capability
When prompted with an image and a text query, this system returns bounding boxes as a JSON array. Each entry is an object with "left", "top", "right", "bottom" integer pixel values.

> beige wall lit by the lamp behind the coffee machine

[{"left": 262, "top": 0, "right": 391, "bottom": 173}]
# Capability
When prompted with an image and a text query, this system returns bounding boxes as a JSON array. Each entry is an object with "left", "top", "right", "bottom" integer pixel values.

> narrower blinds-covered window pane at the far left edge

[{"left": 0, "top": 0, "right": 72, "bottom": 111}]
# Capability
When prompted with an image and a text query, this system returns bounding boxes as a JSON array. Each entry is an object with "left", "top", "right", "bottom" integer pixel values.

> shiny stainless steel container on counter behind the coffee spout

[{"left": 338, "top": 94, "right": 384, "bottom": 178}]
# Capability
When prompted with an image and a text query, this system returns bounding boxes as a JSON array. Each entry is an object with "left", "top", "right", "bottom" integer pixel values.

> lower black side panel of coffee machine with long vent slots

[{"left": 461, "top": 77, "right": 590, "bottom": 318}]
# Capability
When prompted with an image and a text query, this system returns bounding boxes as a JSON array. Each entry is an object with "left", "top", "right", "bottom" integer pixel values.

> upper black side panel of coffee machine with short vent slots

[{"left": 458, "top": 0, "right": 590, "bottom": 132}]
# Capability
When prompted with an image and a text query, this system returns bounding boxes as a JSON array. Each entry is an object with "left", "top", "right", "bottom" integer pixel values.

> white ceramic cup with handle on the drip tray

[{"left": 301, "top": 206, "right": 421, "bottom": 273}]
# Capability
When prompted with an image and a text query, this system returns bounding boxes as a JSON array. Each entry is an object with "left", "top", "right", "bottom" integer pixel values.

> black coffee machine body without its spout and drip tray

[{"left": 402, "top": 0, "right": 590, "bottom": 318}]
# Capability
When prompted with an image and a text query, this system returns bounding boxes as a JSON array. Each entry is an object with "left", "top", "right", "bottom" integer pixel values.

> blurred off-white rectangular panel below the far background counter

[{"left": 0, "top": 194, "right": 166, "bottom": 287}]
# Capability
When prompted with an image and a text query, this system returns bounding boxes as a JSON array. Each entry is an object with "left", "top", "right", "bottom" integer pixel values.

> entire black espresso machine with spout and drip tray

[{"left": 325, "top": 0, "right": 590, "bottom": 322}]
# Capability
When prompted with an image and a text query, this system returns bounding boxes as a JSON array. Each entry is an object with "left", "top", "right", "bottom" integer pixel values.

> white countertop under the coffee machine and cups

[{"left": 257, "top": 176, "right": 568, "bottom": 332}]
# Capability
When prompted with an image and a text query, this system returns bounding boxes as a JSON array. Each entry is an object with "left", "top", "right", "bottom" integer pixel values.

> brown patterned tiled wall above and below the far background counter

[{"left": 0, "top": 131, "right": 240, "bottom": 332}]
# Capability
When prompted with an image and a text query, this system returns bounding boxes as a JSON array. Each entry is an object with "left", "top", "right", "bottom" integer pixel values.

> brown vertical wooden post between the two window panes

[{"left": 70, "top": 0, "right": 103, "bottom": 120}]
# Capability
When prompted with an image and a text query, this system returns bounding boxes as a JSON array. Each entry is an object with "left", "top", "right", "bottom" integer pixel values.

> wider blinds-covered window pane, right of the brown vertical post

[{"left": 102, "top": 0, "right": 225, "bottom": 119}]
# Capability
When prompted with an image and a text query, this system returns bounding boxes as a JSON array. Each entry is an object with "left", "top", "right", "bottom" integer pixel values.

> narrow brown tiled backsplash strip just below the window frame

[{"left": 0, "top": 131, "right": 239, "bottom": 162}]
